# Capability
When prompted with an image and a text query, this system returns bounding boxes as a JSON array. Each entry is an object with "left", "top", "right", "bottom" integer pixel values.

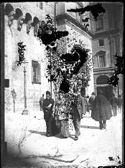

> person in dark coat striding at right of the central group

[{"left": 71, "top": 89, "right": 85, "bottom": 140}]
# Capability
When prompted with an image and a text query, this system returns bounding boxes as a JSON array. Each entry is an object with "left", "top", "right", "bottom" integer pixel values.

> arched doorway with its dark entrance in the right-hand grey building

[{"left": 96, "top": 75, "right": 113, "bottom": 100}]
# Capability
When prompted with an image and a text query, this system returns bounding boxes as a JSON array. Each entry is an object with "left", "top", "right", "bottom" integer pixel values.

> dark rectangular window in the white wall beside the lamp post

[{"left": 32, "top": 61, "right": 41, "bottom": 84}]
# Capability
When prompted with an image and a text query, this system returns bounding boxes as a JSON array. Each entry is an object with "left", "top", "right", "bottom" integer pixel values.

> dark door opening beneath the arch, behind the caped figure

[{"left": 97, "top": 86, "right": 113, "bottom": 100}]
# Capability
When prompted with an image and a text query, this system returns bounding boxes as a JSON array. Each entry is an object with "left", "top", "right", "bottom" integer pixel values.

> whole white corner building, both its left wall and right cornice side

[{"left": 4, "top": 2, "right": 94, "bottom": 113}]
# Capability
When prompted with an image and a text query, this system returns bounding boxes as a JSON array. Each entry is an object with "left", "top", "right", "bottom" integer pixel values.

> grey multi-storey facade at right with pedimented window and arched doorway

[{"left": 91, "top": 2, "right": 123, "bottom": 98}]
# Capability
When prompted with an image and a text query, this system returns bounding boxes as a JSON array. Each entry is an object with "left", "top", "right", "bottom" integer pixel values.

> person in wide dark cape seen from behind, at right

[{"left": 91, "top": 90, "right": 112, "bottom": 129}]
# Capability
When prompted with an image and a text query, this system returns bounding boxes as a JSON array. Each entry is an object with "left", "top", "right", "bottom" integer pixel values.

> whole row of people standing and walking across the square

[{"left": 40, "top": 89, "right": 122, "bottom": 140}]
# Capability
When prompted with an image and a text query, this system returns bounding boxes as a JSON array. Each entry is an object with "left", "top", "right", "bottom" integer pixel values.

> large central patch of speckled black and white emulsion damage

[{"left": 37, "top": 15, "right": 90, "bottom": 119}]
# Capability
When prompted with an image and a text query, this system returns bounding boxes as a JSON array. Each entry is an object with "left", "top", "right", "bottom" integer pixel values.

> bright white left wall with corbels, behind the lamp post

[{"left": 4, "top": 2, "right": 53, "bottom": 113}]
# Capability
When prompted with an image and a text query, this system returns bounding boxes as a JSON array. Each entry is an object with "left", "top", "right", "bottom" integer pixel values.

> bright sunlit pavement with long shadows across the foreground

[{"left": 4, "top": 109, "right": 123, "bottom": 168}]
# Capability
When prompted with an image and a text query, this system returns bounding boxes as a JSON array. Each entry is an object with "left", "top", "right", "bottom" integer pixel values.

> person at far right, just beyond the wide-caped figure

[{"left": 109, "top": 93, "right": 118, "bottom": 116}]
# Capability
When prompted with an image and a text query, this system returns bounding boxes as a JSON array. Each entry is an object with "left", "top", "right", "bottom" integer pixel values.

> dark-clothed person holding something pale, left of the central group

[{"left": 43, "top": 91, "right": 54, "bottom": 136}]
